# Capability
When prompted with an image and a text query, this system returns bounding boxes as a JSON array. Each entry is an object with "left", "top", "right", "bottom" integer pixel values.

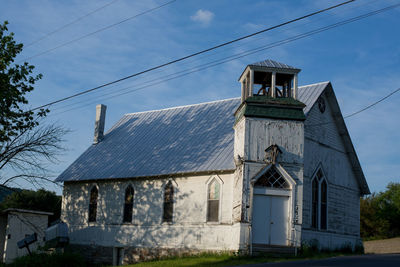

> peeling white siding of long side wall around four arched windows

[{"left": 62, "top": 174, "right": 248, "bottom": 250}]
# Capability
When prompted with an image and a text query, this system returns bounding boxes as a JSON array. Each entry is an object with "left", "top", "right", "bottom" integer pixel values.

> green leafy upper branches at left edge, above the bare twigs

[{"left": 0, "top": 21, "right": 48, "bottom": 143}]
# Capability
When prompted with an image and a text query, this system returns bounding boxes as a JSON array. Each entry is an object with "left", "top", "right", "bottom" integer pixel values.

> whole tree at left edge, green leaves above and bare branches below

[{"left": 0, "top": 21, "right": 67, "bottom": 185}]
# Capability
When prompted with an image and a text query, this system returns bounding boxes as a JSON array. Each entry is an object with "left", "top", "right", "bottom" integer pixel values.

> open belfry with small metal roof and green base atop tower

[{"left": 235, "top": 59, "right": 305, "bottom": 121}]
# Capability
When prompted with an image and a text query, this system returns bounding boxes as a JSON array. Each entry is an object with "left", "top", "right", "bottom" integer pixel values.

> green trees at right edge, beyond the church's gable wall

[{"left": 360, "top": 183, "right": 400, "bottom": 239}]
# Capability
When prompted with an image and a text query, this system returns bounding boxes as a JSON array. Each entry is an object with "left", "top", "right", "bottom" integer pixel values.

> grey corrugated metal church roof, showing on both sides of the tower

[{"left": 56, "top": 82, "right": 328, "bottom": 181}]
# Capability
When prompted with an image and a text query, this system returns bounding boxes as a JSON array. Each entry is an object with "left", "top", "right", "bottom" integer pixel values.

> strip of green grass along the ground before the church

[{"left": 124, "top": 252, "right": 352, "bottom": 267}]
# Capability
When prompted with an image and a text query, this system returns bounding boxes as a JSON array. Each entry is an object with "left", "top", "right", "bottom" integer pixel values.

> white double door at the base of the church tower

[{"left": 252, "top": 195, "right": 289, "bottom": 246}]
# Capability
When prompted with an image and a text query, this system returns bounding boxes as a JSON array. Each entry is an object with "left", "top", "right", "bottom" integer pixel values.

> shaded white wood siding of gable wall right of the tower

[{"left": 303, "top": 93, "right": 360, "bottom": 250}]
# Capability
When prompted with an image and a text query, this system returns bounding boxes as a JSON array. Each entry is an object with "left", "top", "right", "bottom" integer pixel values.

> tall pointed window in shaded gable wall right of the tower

[{"left": 311, "top": 168, "right": 328, "bottom": 230}]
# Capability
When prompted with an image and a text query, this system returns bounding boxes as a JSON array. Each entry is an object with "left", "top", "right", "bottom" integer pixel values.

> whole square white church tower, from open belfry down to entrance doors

[{"left": 233, "top": 60, "right": 305, "bottom": 250}]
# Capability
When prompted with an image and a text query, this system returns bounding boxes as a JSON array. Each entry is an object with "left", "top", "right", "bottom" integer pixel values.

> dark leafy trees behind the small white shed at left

[{"left": 0, "top": 189, "right": 61, "bottom": 225}]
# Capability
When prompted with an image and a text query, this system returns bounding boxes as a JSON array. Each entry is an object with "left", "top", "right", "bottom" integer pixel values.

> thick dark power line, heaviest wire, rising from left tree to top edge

[{"left": 30, "top": 0, "right": 356, "bottom": 111}]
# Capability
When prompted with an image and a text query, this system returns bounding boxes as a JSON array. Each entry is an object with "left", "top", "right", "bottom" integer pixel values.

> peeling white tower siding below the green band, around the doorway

[{"left": 234, "top": 117, "right": 304, "bottom": 245}]
